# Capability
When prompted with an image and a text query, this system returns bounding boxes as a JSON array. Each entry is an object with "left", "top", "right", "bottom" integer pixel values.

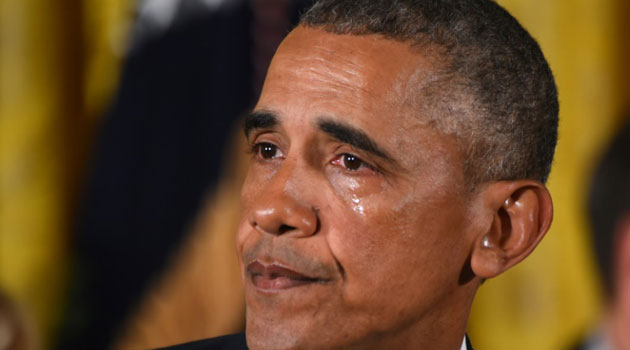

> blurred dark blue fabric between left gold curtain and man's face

[{"left": 57, "top": 0, "right": 310, "bottom": 350}]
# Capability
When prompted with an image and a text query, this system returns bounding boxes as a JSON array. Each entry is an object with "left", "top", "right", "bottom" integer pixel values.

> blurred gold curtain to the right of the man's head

[{"left": 469, "top": 0, "right": 630, "bottom": 350}]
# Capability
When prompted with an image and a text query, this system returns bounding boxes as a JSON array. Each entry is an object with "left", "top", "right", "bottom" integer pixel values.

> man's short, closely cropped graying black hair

[{"left": 300, "top": 0, "right": 558, "bottom": 187}]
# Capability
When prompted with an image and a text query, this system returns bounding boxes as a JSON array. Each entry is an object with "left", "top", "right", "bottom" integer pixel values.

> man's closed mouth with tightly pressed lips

[{"left": 247, "top": 260, "right": 326, "bottom": 293}]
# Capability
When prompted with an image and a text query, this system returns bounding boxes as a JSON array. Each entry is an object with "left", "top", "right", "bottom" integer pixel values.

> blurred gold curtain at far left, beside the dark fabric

[{"left": 0, "top": 0, "right": 132, "bottom": 347}]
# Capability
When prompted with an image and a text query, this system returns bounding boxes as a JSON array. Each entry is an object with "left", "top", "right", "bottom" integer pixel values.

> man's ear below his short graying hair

[{"left": 470, "top": 180, "right": 553, "bottom": 278}]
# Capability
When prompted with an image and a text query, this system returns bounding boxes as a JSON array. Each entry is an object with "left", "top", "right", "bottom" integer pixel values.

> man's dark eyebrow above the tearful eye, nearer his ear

[{"left": 317, "top": 118, "right": 397, "bottom": 165}]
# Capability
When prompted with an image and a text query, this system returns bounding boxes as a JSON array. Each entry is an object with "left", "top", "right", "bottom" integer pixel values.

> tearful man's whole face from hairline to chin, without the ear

[{"left": 237, "top": 27, "right": 478, "bottom": 350}]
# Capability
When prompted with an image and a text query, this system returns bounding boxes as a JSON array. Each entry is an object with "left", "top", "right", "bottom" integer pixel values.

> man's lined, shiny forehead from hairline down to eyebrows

[{"left": 257, "top": 26, "right": 460, "bottom": 163}]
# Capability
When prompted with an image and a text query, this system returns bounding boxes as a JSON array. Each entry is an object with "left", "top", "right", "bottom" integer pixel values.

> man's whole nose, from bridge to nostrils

[{"left": 252, "top": 157, "right": 319, "bottom": 237}]
